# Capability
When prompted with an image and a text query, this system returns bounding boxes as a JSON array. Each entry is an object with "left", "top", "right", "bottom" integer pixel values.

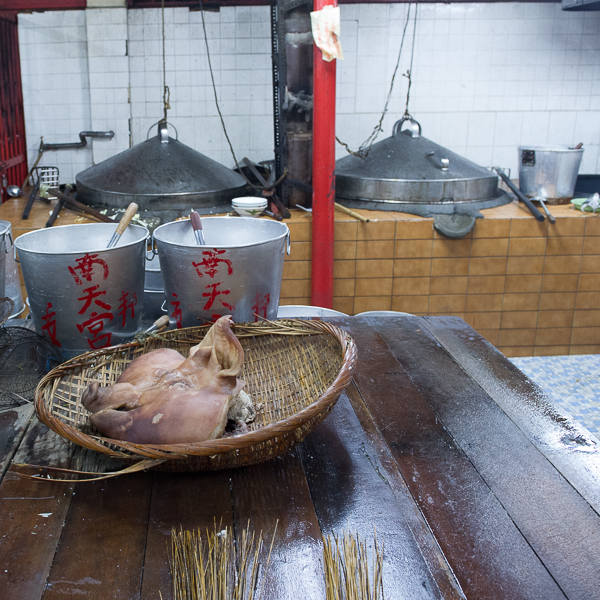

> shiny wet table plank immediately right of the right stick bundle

[{"left": 301, "top": 394, "right": 464, "bottom": 600}]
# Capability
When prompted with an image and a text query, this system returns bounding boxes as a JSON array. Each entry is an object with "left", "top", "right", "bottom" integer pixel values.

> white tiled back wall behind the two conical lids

[{"left": 19, "top": 3, "right": 600, "bottom": 181}]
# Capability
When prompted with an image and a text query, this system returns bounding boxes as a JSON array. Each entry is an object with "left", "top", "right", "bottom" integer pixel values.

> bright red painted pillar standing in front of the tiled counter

[{"left": 311, "top": 0, "right": 337, "bottom": 308}]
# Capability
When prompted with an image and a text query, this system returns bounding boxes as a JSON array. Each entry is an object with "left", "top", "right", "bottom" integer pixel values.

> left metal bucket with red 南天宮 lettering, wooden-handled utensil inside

[{"left": 15, "top": 223, "right": 150, "bottom": 359}]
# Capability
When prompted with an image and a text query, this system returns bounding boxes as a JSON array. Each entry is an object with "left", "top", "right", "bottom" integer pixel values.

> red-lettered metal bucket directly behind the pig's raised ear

[{"left": 153, "top": 217, "right": 290, "bottom": 328}]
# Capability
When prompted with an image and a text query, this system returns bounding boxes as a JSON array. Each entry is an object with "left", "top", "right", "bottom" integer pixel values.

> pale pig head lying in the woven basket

[{"left": 81, "top": 316, "right": 245, "bottom": 444}]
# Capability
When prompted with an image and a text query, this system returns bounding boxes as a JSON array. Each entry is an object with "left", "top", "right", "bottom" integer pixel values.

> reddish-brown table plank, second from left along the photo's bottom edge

[{"left": 42, "top": 473, "right": 152, "bottom": 600}]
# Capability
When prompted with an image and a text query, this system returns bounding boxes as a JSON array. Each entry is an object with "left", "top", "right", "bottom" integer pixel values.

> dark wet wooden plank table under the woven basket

[{"left": 0, "top": 316, "right": 600, "bottom": 600}]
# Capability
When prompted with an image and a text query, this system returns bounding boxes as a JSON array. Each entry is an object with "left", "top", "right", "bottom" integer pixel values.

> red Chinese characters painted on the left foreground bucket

[{"left": 42, "top": 253, "right": 137, "bottom": 350}]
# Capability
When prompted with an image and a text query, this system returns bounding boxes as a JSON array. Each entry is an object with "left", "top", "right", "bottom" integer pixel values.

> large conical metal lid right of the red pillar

[{"left": 336, "top": 117, "right": 502, "bottom": 204}]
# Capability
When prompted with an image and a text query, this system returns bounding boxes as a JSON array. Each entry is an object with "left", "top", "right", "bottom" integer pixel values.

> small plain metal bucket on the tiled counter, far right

[{"left": 519, "top": 146, "right": 583, "bottom": 204}]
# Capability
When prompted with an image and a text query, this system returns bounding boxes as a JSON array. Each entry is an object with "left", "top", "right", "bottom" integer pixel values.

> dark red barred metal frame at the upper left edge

[{"left": 0, "top": 13, "right": 27, "bottom": 202}]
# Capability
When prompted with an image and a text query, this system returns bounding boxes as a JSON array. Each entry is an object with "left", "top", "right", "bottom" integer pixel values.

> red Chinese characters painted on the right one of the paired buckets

[{"left": 171, "top": 248, "right": 270, "bottom": 329}]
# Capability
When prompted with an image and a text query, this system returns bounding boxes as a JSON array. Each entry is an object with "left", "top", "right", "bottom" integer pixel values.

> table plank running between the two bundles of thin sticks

[{"left": 231, "top": 450, "right": 325, "bottom": 600}]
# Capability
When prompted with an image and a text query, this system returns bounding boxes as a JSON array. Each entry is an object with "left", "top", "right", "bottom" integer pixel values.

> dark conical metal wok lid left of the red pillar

[{"left": 76, "top": 122, "right": 246, "bottom": 210}]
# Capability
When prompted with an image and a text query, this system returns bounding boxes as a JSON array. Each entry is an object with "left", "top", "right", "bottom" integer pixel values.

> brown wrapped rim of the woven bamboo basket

[{"left": 34, "top": 319, "right": 358, "bottom": 460}]
